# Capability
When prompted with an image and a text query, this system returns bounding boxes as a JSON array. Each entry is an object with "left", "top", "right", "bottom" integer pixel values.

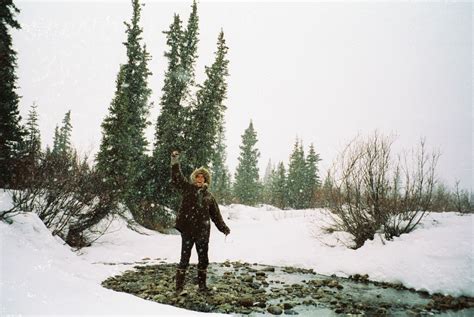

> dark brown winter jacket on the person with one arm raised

[{"left": 171, "top": 163, "right": 229, "bottom": 240}]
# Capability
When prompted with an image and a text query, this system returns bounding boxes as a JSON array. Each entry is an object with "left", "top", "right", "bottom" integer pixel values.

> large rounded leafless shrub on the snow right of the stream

[{"left": 325, "top": 132, "right": 439, "bottom": 248}]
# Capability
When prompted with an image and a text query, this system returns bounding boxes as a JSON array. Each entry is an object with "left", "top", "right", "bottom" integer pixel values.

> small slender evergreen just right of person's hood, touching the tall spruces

[{"left": 211, "top": 127, "right": 232, "bottom": 205}]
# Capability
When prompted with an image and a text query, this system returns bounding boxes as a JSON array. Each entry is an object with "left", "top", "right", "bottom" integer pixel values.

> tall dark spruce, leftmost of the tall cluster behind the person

[{"left": 97, "top": 0, "right": 151, "bottom": 217}]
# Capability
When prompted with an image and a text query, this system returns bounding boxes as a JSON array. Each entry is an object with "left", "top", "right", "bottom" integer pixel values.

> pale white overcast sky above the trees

[{"left": 13, "top": 0, "right": 473, "bottom": 188}]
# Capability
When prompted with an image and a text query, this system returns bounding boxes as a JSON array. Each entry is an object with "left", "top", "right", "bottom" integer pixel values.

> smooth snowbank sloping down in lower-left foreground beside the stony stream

[{"left": 0, "top": 207, "right": 224, "bottom": 316}]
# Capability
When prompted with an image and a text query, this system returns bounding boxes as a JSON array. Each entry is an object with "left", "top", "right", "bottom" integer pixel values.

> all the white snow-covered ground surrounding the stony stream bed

[{"left": 0, "top": 194, "right": 474, "bottom": 316}]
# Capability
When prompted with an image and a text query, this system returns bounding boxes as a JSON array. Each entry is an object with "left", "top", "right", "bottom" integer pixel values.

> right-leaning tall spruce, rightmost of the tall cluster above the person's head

[{"left": 189, "top": 31, "right": 229, "bottom": 167}]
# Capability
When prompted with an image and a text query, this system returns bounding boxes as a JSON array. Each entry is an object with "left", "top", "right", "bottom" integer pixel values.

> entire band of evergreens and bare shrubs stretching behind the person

[{"left": 0, "top": 0, "right": 473, "bottom": 247}]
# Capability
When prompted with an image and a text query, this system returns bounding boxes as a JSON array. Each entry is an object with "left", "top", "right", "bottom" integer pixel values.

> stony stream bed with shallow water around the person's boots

[{"left": 102, "top": 261, "right": 474, "bottom": 316}]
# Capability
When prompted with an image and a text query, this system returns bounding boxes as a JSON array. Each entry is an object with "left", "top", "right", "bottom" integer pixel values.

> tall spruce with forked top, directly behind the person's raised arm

[{"left": 150, "top": 1, "right": 203, "bottom": 209}]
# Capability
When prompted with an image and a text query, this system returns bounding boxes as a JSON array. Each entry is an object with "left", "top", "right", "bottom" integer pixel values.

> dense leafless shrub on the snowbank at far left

[{"left": 3, "top": 152, "right": 114, "bottom": 247}]
